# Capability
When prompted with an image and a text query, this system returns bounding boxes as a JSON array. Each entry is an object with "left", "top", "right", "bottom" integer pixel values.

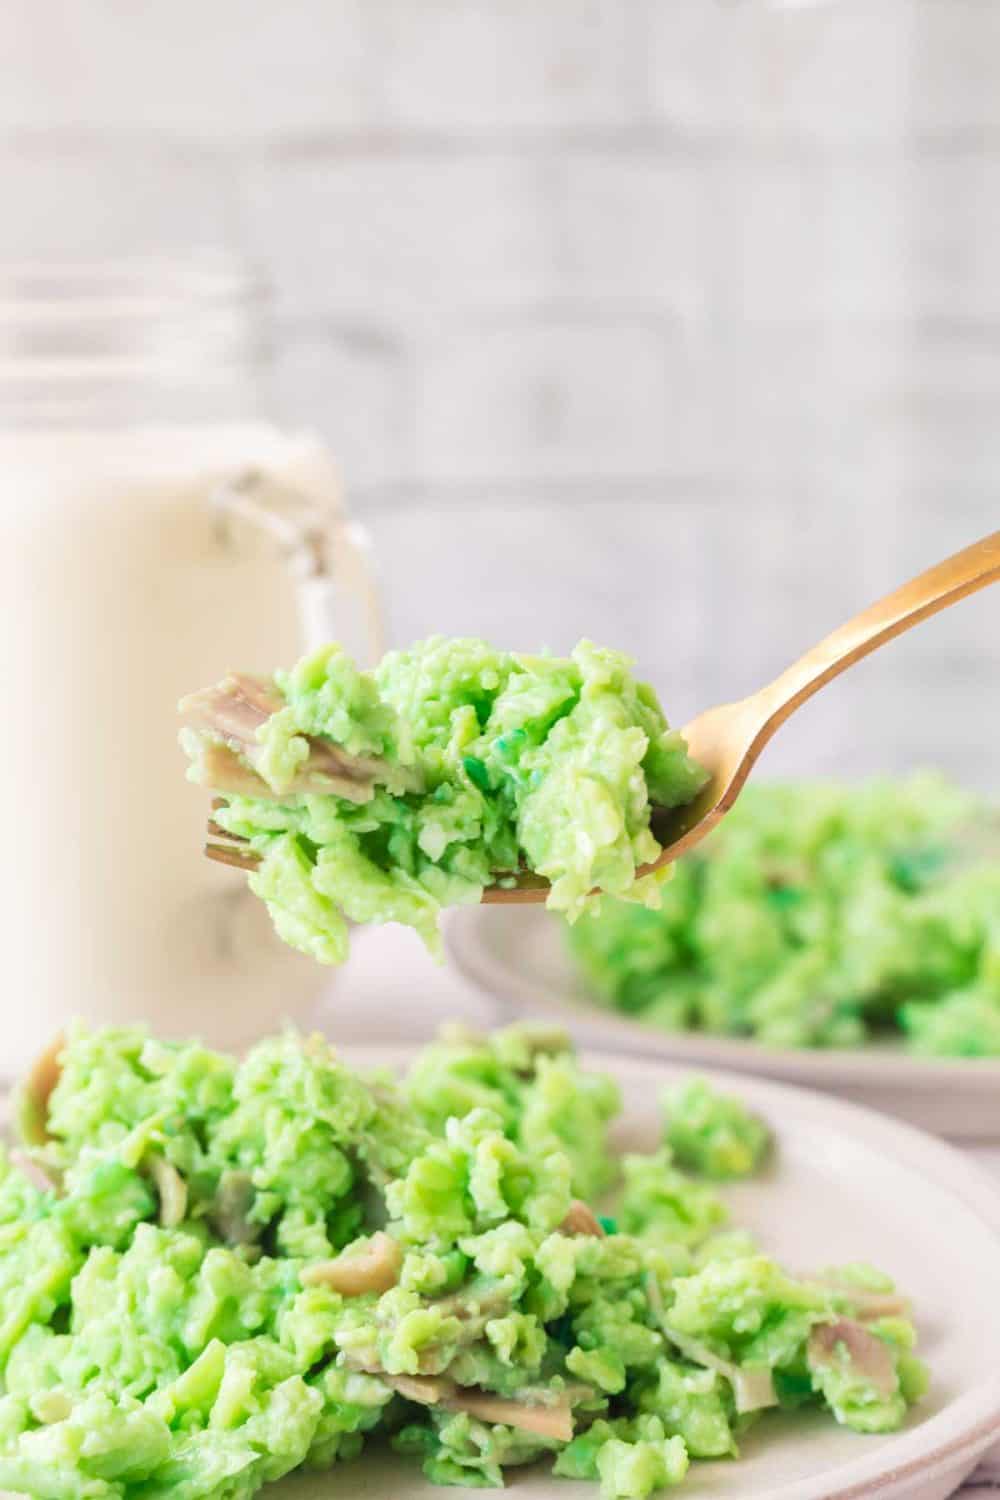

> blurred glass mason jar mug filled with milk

[{"left": 0, "top": 255, "right": 378, "bottom": 1077}]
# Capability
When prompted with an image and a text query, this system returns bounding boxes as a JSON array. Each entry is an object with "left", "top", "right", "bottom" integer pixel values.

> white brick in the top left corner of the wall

[{"left": 0, "top": 0, "right": 372, "bottom": 144}]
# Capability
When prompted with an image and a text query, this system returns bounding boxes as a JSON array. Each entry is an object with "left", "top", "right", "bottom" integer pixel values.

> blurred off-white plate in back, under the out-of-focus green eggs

[{"left": 445, "top": 906, "right": 1000, "bottom": 1140}]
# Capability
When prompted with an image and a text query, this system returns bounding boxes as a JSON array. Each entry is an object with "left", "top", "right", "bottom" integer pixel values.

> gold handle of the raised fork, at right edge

[{"left": 756, "top": 531, "right": 1000, "bottom": 732}]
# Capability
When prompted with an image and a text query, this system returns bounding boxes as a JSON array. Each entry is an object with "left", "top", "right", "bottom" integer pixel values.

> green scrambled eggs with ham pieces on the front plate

[{"left": 0, "top": 1028, "right": 925, "bottom": 1500}]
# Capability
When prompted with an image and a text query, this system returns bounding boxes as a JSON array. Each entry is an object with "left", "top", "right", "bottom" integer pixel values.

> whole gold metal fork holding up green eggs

[{"left": 205, "top": 531, "right": 1000, "bottom": 903}]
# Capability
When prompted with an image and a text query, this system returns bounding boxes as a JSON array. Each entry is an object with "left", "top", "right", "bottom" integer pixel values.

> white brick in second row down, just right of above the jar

[{"left": 237, "top": 146, "right": 552, "bottom": 321}]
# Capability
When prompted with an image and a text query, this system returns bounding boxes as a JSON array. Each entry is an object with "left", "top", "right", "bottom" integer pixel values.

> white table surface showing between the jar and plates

[{"left": 321, "top": 927, "right": 1000, "bottom": 1497}]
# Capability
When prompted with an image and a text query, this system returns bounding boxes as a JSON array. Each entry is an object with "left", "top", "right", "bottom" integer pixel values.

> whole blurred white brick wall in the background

[{"left": 0, "top": 0, "right": 1000, "bottom": 785}]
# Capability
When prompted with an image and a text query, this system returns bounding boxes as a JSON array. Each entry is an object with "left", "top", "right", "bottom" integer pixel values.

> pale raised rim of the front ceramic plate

[{"left": 342, "top": 1043, "right": 1000, "bottom": 1500}]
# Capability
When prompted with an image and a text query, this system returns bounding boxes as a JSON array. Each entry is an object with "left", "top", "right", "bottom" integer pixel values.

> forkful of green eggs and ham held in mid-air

[{"left": 181, "top": 636, "right": 705, "bottom": 963}]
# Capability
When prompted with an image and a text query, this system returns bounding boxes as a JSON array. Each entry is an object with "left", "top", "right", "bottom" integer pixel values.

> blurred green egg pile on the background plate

[{"left": 568, "top": 774, "right": 1000, "bottom": 1058}]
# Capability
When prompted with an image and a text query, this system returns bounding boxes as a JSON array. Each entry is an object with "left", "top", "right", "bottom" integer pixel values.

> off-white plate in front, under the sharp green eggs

[{"left": 265, "top": 1049, "right": 1000, "bottom": 1500}]
